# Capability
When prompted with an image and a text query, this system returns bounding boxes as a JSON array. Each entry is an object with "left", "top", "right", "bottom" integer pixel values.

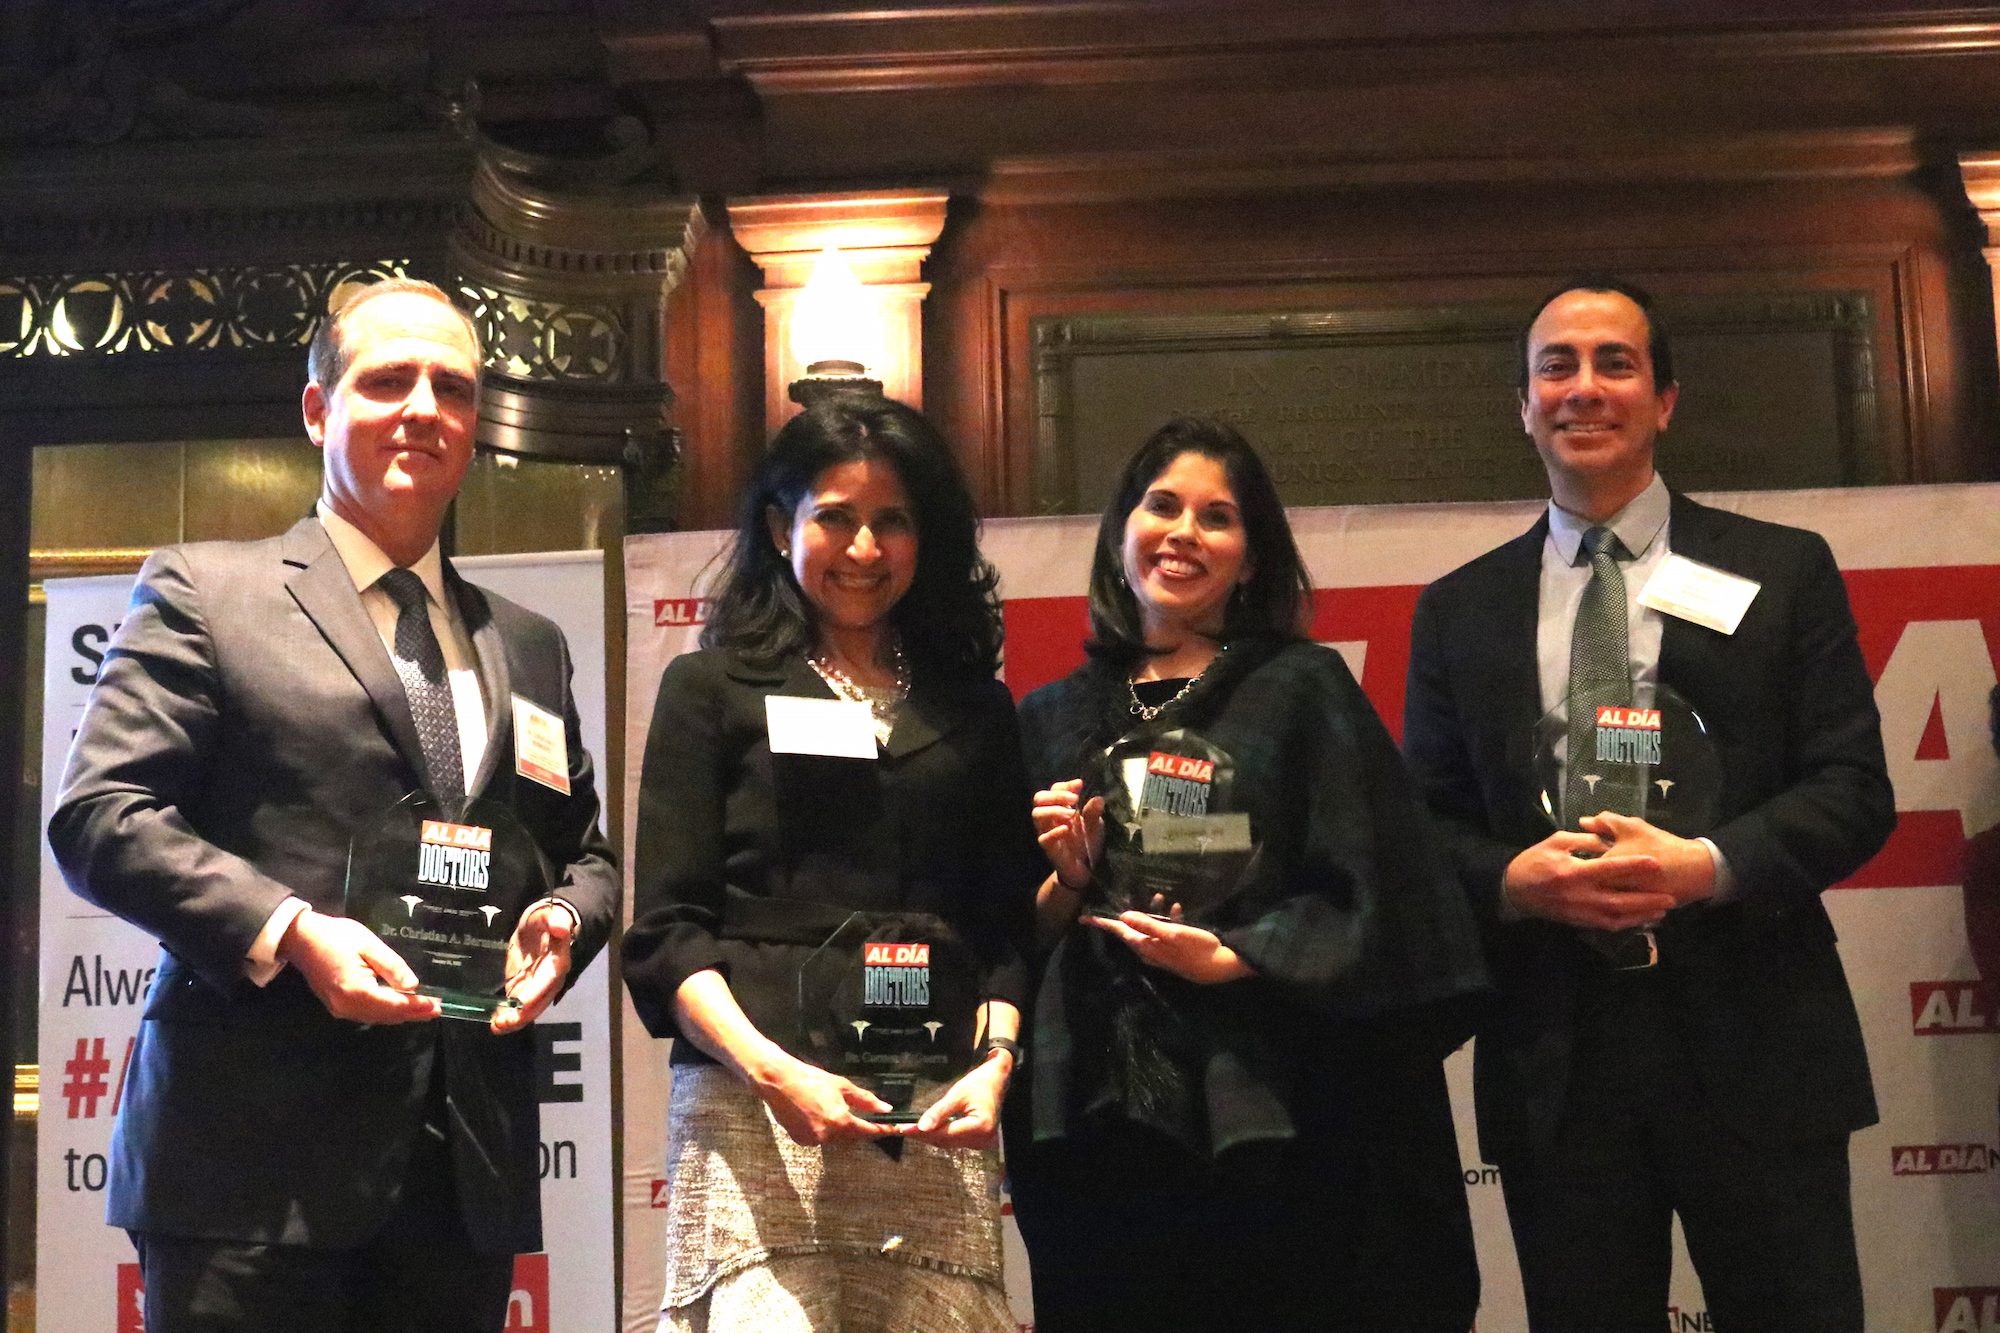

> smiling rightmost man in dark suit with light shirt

[{"left": 1404, "top": 280, "right": 1896, "bottom": 1333}]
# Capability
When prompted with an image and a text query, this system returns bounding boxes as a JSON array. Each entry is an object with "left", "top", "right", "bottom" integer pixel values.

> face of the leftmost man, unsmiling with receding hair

[{"left": 302, "top": 292, "right": 480, "bottom": 564}]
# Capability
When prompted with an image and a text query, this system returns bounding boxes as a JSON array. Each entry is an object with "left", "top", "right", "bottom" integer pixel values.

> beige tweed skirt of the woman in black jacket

[{"left": 660, "top": 1065, "right": 1014, "bottom": 1333}]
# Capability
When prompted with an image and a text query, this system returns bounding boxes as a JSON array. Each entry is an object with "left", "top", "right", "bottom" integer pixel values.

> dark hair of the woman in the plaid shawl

[{"left": 1084, "top": 416, "right": 1312, "bottom": 671}]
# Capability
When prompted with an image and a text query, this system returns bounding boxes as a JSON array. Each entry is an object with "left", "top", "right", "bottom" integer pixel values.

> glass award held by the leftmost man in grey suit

[{"left": 346, "top": 791, "right": 550, "bottom": 1023}]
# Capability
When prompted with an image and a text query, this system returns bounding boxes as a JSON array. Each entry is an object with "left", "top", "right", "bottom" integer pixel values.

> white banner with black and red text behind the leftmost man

[{"left": 36, "top": 550, "right": 616, "bottom": 1333}]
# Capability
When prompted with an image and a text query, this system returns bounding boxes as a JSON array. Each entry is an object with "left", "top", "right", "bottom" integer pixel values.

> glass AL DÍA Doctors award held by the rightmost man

[{"left": 1534, "top": 683, "right": 1722, "bottom": 969}]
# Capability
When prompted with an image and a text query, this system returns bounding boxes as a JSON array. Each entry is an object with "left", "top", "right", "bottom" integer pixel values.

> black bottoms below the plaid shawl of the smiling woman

[{"left": 1008, "top": 1061, "right": 1480, "bottom": 1333}]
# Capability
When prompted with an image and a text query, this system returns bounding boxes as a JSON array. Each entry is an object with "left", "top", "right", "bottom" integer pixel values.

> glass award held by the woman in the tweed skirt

[{"left": 772, "top": 913, "right": 982, "bottom": 1125}]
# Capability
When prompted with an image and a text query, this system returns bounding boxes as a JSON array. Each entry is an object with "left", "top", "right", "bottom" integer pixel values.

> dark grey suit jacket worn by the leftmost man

[{"left": 48, "top": 518, "right": 618, "bottom": 1251}]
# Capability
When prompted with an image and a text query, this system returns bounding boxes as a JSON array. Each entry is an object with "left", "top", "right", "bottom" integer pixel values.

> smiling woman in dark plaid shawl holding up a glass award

[{"left": 1008, "top": 420, "right": 1484, "bottom": 1333}]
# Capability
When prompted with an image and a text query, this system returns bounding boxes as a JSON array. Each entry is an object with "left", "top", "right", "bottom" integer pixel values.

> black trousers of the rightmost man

[{"left": 1500, "top": 971, "right": 1862, "bottom": 1333}]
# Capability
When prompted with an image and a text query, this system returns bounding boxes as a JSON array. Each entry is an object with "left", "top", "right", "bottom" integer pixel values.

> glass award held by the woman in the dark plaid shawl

[{"left": 1082, "top": 727, "right": 1258, "bottom": 923}]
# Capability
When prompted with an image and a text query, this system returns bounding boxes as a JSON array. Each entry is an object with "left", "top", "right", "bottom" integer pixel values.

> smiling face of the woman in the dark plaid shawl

[{"left": 1120, "top": 452, "right": 1250, "bottom": 640}]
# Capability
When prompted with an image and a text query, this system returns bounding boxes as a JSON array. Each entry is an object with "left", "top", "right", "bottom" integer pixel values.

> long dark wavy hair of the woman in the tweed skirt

[{"left": 702, "top": 394, "right": 1002, "bottom": 681}]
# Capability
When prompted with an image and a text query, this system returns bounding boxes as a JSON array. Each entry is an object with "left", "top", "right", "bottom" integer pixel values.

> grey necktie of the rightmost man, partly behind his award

[{"left": 1564, "top": 528, "right": 1642, "bottom": 825}]
